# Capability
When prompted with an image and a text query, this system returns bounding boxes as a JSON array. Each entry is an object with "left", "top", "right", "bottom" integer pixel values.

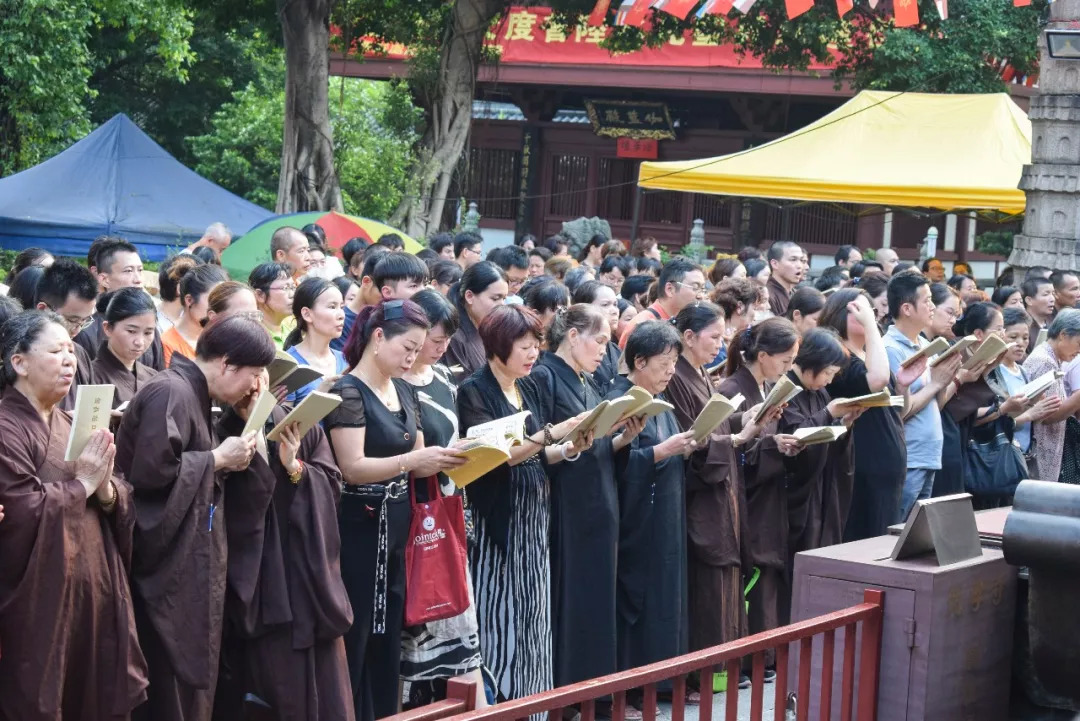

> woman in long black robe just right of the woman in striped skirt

[{"left": 532, "top": 303, "right": 642, "bottom": 685}]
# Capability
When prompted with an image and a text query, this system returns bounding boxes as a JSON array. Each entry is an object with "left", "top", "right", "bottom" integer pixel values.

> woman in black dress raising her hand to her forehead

[{"left": 818, "top": 288, "right": 919, "bottom": 541}]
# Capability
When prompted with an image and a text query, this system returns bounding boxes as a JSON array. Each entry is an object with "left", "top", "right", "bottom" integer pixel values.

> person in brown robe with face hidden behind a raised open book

[{"left": 217, "top": 406, "right": 354, "bottom": 721}]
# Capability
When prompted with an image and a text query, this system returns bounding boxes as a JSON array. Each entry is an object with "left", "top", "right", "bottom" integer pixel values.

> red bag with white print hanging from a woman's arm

[{"left": 405, "top": 476, "right": 469, "bottom": 626}]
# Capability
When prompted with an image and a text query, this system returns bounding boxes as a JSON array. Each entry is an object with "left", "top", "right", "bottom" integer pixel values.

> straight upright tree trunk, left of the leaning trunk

[{"left": 276, "top": 0, "right": 343, "bottom": 213}]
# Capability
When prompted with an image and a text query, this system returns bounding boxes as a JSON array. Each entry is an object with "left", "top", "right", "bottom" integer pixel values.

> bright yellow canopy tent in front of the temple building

[{"left": 637, "top": 91, "right": 1031, "bottom": 214}]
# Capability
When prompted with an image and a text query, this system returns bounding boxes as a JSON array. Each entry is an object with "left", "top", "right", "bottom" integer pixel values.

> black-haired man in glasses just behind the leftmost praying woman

[{"left": 38, "top": 258, "right": 100, "bottom": 410}]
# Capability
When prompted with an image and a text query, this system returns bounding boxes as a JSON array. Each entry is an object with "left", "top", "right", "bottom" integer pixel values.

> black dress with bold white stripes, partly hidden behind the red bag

[{"left": 402, "top": 365, "right": 482, "bottom": 683}]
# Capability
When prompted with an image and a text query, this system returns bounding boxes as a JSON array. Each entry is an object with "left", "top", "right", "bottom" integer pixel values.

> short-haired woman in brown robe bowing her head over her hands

[{"left": 117, "top": 315, "right": 275, "bottom": 721}]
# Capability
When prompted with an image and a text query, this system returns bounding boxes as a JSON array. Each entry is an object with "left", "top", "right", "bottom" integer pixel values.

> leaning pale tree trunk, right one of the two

[{"left": 390, "top": 0, "right": 507, "bottom": 239}]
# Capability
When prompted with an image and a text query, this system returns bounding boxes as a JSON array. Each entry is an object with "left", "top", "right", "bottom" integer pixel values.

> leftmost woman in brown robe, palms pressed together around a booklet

[{"left": 0, "top": 311, "right": 147, "bottom": 721}]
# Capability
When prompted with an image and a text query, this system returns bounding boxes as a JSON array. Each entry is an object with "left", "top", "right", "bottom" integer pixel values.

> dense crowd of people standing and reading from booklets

[{"left": 0, "top": 226, "right": 1080, "bottom": 721}]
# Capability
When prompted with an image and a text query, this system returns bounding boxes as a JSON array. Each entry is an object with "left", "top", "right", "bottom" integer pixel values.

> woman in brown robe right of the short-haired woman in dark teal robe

[{"left": 667, "top": 302, "right": 780, "bottom": 695}]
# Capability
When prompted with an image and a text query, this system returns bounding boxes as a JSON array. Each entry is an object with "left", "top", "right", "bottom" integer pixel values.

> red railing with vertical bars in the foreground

[{"left": 390, "top": 589, "right": 885, "bottom": 721}]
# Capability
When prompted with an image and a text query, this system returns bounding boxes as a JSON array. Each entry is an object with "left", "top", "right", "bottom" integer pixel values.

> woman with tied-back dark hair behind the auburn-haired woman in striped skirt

[{"left": 445, "top": 260, "right": 510, "bottom": 381}]
